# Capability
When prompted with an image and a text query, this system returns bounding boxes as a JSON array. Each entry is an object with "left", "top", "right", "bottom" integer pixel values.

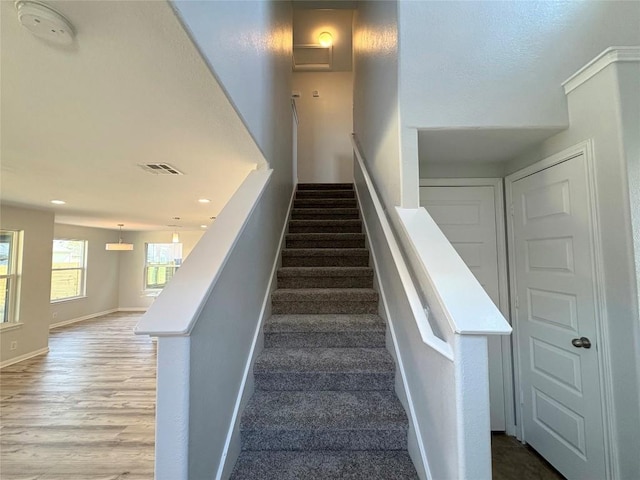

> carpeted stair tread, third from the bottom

[{"left": 254, "top": 347, "right": 395, "bottom": 373}]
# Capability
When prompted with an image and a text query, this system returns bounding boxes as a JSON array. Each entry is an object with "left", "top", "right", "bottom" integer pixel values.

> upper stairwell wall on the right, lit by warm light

[{"left": 353, "top": 1, "right": 402, "bottom": 208}]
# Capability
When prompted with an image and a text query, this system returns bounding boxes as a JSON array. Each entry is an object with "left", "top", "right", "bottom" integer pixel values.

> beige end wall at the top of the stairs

[{"left": 292, "top": 72, "right": 353, "bottom": 183}]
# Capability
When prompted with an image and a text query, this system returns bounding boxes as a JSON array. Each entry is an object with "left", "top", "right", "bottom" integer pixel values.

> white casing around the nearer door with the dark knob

[{"left": 505, "top": 139, "right": 616, "bottom": 479}]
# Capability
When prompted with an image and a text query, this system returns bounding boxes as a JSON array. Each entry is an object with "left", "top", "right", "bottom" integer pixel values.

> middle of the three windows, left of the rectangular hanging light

[{"left": 51, "top": 240, "right": 87, "bottom": 302}]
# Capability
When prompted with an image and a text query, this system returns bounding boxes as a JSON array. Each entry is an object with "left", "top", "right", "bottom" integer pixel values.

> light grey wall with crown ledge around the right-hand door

[{"left": 507, "top": 64, "right": 640, "bottom": 478}]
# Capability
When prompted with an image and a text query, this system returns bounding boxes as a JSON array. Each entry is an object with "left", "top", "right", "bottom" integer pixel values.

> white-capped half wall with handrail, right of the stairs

[{"left": 353, "top": 138, "right": 511, "bottom": 479}]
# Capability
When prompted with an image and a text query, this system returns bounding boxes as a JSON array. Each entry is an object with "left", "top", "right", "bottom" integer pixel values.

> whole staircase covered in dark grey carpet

[{"left": 231, "top": 184, "right": 417, "bottom": 480}]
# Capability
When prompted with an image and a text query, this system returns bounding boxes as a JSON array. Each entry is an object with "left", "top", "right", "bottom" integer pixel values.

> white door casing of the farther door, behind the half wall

[{"left": 420, "top": 178, "right": 516, "bottom": 435}]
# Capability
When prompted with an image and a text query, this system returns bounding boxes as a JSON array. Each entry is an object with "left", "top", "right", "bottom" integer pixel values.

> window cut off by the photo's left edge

[{"left": 0, "top": 230, "right": 18, "bottom": 323}]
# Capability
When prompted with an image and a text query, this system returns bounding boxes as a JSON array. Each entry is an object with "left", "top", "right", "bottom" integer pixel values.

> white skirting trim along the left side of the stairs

[{"left": 216, "top": 188, "right": 296, "bottom": 480}]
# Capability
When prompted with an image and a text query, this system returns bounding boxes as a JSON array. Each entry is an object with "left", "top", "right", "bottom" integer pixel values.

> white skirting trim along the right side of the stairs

[{"left": 354, "top": 179, "right": 430, "bottom": 480}]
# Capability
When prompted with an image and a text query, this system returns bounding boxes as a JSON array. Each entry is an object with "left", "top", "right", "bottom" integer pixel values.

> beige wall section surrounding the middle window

[{"left": 49, "top": 223, "right": 120, "bottom": 324}]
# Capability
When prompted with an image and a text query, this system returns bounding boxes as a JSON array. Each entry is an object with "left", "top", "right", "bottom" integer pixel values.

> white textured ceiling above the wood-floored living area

[{"left": 0, "top": 1, "right": 264, "bottom": 230}]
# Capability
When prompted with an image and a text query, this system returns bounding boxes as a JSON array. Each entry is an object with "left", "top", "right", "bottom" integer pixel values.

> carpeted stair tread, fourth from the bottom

[{"left": 264, "top": 314, "right": 387, "bottom": 333}]
